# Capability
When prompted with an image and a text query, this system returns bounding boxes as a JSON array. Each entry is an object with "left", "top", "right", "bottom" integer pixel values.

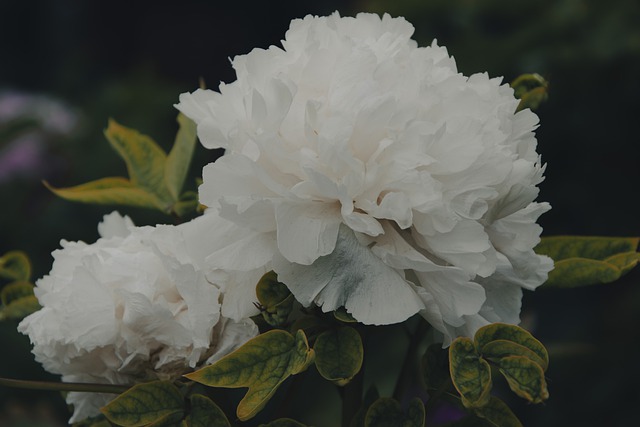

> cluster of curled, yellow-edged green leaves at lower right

[{"left": 449, "top": 323, "right": 549, "bottom": 412}]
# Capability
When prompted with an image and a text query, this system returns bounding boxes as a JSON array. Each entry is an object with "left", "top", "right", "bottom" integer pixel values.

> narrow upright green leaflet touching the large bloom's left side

[{"left": 164, "top": 113, "right": 196, "bottom": 200}]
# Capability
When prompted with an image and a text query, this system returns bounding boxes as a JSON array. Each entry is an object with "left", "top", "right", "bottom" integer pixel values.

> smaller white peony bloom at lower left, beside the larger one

[{"left": 18, "top": 212, "right": 258, "bottom": 422}]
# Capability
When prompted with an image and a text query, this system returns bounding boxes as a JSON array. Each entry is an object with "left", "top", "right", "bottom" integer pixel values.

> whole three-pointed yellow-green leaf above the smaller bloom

[{"left": 44, "top": 114, "right": 198, "bottom": 216}]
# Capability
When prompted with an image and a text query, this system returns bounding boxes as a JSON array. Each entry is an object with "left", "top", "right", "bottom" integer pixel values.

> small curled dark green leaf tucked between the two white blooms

[{"left": 256, "top": 271, "right": 294, "bottom": 326}]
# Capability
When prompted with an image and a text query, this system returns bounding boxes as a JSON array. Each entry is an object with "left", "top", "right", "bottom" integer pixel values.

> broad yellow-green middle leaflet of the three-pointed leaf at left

[{"left": 104, "top": 120, "right": 177, "bottom": 205}]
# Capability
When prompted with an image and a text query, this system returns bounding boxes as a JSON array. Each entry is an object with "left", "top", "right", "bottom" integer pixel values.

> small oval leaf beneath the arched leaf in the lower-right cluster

[{"left": 497, "top": 356, "right": 549, "bottom": 403}]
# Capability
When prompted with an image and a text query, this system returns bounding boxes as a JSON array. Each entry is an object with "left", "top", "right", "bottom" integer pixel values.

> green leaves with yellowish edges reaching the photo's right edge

[{"left": 535, "top": 236, "right": 640, "bottom": 288}]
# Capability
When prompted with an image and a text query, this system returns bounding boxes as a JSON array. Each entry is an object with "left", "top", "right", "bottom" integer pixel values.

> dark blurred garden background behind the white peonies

[{"left": 0, "top": 0, "right": 640, "bottom": 426}]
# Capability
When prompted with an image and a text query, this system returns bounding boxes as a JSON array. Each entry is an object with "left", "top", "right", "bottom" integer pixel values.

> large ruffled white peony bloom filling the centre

[{"left": 177, "top": 13, "right": 552, "bottom": 345}]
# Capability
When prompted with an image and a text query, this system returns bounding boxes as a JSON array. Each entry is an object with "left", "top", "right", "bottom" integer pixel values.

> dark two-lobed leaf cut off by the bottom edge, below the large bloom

[{"left": 364, "top": 397, "right": 425, "bottom": 427}]
